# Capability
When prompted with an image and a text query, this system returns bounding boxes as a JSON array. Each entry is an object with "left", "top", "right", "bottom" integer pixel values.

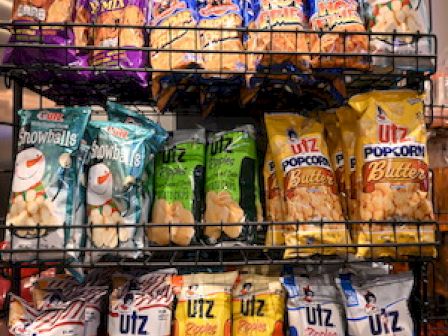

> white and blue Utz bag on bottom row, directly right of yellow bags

[{"left": 281, "top": 276, "right": 344, "bottom": 336}]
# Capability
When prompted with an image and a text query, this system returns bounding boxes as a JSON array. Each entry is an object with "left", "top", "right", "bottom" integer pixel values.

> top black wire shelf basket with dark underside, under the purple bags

[{"left": 0, "top": 21, "right": 437, "bottom": 110}]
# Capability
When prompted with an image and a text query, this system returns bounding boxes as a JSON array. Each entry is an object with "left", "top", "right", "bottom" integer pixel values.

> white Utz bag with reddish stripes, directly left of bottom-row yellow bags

[{"left": 108, "top": 271, "right": 174, "bottom": 336}]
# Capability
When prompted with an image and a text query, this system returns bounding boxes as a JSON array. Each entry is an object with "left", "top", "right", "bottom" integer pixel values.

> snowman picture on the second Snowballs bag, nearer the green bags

[{"left": 87, "top": 163, "right": 130, "bottom": 248}]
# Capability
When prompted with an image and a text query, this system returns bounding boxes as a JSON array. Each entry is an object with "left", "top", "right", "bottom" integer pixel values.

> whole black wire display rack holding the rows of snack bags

[{"left": 0, "top": 2, "right": 448, "bottom": 336}]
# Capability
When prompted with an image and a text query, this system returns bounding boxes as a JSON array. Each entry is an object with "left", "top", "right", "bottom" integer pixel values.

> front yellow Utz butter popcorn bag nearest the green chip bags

[{"left": 265, "top": 113, "right": 350, "bottom": 258}]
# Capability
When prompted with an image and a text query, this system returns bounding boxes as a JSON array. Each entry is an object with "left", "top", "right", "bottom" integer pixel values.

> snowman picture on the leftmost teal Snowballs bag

[{"left": 7, "top": 147, "right": 63, "bottom": 238}]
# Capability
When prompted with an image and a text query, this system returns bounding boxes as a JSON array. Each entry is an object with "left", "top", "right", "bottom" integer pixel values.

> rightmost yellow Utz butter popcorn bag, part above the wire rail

[{"left": 350, "top": 90, "right": 433, "bottom": 220}]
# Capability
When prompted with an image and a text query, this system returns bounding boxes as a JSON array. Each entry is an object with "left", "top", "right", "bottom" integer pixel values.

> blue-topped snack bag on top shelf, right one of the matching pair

[{"left": 197, "top": 0, "right": 246, "bottom": 78}]
